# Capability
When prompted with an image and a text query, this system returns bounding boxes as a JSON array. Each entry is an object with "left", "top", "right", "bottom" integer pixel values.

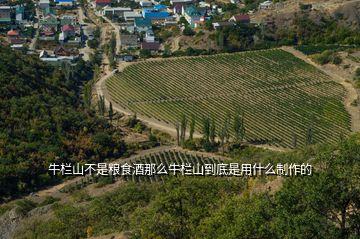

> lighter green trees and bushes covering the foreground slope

[{"left": 15, "top": 135, "right": 360, "bottom": 239}]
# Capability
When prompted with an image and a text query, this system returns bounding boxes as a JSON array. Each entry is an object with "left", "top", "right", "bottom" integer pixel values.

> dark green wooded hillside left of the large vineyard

[{"left": 0, "top": 47, "right": 125, "bottom": 201}]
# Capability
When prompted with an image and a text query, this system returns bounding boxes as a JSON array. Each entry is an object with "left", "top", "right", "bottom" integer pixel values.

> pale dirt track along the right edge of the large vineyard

[{"left": 282, "top": 47, "right": 360, "bottom": 132}]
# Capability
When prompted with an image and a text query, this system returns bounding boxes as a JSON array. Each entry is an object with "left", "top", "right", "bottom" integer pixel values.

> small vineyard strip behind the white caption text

[{"left": 60, "top": 150, "right": 224, "bottom": 193}]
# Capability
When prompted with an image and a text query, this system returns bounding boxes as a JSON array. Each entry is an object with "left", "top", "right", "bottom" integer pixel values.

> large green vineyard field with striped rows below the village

[{"left": 106, "top": 49, "right": 350, "bottom": 147}]
